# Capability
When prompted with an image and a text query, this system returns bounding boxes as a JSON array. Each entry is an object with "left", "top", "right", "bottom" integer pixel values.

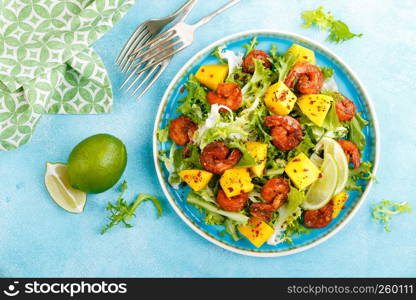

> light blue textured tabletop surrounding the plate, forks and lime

[{"left": 0, "top": 0, "right": 416, "bottom": 277}]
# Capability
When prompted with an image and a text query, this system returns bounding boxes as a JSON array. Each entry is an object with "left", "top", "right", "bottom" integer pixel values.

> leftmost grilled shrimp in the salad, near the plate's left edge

[{"left": 169, "top": 115, "right": 198, "bottom": 146}]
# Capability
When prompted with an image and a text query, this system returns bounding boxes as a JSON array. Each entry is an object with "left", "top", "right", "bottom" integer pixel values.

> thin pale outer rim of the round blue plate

[{"left": 153, "top": 29, "right": 380, "bottom": 257}]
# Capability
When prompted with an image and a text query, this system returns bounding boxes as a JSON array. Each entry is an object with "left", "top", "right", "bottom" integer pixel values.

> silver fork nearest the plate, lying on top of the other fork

[{"left": 123, "top": 0, "right": 241, "bottom": 86}]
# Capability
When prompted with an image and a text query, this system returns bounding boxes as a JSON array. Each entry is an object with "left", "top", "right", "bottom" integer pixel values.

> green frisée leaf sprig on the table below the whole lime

[{"left": 101, "top": 181, "right": 163, "bottom": 234}]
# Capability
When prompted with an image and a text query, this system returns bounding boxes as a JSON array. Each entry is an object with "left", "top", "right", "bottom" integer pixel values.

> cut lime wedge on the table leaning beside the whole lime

[{"left": 45, "top": 163, "right": 87, "bottom": 214}]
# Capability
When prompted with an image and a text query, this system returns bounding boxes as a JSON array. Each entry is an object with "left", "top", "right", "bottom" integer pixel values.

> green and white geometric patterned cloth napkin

[{"left": 0, "top": 0, "right": 134, "bottom": 151}]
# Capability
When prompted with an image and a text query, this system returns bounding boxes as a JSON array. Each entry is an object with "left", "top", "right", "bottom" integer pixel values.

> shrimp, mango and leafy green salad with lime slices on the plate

[{"left": 158, "top": 39, "right": 372, "bottom": 247}]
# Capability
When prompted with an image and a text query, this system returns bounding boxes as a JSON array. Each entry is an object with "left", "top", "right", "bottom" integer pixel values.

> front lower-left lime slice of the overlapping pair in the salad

[{"left": 302, "top": 153, "right": 338, "bottom": 210}]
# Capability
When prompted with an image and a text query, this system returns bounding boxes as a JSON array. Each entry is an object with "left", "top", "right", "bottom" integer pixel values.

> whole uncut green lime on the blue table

[{"left": 68, "top": 134, "right": 127, "bottom": 194}]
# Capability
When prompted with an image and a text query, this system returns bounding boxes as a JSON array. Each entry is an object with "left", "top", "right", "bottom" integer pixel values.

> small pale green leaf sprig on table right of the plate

[{"left": 372, "top": 200, "right": 412, "bottom": 232}]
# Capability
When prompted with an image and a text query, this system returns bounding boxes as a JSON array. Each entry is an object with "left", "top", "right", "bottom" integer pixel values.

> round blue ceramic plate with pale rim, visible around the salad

[{"left": 153, "top": 31, "right": 379, "bottom": 257}]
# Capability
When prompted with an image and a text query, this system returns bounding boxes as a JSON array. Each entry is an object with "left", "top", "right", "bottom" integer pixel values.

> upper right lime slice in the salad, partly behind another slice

[{"left": 316, "top": 137, "right": 349, "bottom": 194}]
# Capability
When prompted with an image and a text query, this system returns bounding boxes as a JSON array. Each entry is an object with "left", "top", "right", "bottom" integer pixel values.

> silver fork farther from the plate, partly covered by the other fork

[{"left": 116, "top": 0, "right": 197, "bottom": 72}]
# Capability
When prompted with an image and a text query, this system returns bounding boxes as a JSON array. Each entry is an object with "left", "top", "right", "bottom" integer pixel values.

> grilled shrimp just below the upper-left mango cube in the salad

[{"left": 207, "top": 82, "right": 243, "bottom": 112}]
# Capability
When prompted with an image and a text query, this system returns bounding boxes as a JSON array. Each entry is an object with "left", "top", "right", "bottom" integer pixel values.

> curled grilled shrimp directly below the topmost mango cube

[{"left": 285, "top": 62, "right": 324, "bottom": 94}]
